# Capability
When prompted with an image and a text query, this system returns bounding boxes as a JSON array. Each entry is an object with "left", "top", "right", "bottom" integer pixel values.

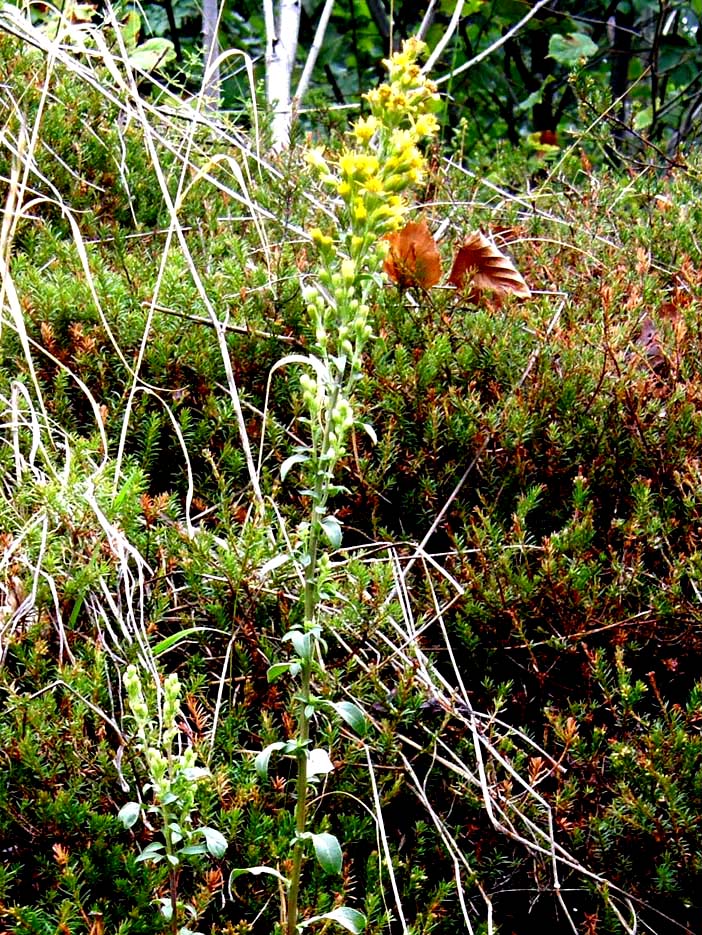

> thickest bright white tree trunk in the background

[{"left": 263, "top": 0, "right": 301, "bottom": 150}]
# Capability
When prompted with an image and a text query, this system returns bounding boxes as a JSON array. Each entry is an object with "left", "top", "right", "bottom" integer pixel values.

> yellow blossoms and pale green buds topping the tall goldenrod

[{"left": 305, "top": 39, "right": 438, "bottom": 372}]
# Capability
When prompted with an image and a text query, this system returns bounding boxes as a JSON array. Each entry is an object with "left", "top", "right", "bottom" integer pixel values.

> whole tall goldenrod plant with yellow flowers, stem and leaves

[{"left": 257, "top": 39, "right": 438, "bottom": 935}]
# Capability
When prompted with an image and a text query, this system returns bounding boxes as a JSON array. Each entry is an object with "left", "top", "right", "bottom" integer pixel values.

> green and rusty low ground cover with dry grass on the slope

[{"left": 0, "top": 12, "right": 702, "bottom": 935}]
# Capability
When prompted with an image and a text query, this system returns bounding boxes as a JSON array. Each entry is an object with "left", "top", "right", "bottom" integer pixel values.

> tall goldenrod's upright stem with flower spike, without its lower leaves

[{"left": 283, "top": 39, "right": 438, "bottom": 935}]
